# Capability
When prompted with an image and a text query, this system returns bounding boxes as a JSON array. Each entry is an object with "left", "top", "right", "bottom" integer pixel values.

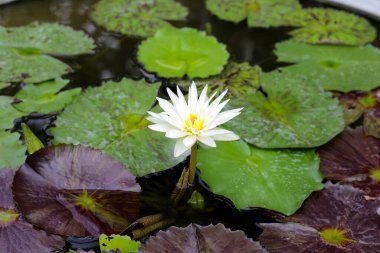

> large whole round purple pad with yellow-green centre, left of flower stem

[{"left": 13, "top": 145, "right": 140, "bottom": 236}]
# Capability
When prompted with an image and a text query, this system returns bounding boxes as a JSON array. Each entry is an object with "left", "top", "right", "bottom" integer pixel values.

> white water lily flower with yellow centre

[{"left": 147, "top": 82, "right": 242, "bottom": 157}]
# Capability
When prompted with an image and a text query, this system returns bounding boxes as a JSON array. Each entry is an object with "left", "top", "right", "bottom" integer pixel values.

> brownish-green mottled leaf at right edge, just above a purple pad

[{"left": 338, "top": 89, "right": 380, "bottom": 138}]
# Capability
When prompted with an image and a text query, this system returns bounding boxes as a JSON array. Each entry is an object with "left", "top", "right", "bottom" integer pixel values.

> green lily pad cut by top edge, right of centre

[{"left": 206, "top": 0, "right": 301, "bottom": 27}]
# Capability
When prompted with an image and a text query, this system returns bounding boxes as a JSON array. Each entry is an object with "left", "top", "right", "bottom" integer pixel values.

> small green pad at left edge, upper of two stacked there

[{"left": 0, "top": 96, "right": 23, "bottom": 131}]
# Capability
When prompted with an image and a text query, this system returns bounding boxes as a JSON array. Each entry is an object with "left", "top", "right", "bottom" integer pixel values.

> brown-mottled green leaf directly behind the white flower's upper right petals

[{"left": 174, "top": 62, "right": 261, "bottom": 97}]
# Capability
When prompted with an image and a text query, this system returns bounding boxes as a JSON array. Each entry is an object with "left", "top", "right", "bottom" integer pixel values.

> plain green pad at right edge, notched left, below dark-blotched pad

[{"left": 275, "top": 41, "right": 380, "bottom": 92}]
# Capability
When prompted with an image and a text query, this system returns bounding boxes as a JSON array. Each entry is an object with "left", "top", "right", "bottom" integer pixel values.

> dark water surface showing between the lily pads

[{"left": 0, "top": 0, "right": 380, "bottom": 249}]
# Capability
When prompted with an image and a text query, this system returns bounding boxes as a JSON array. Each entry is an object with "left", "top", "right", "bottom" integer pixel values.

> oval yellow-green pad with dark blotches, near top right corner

[{"left": 290, "top": 8, "right": 376, "bottom": 46}]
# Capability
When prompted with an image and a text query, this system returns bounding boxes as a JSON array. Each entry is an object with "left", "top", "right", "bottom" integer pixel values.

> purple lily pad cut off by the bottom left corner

[{"left": 0, "top": 169, "right": 64, "bottom": 253}]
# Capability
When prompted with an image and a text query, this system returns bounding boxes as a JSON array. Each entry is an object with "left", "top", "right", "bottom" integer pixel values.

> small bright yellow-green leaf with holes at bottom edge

[{"left": 99, "top": 234, "right": 141, "bottom": 253}]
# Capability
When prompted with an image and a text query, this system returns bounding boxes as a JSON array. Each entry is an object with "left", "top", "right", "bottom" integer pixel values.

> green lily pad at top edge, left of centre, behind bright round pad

[{"left": 92, "top": 0, "right": 188, "bottom": 37}]
